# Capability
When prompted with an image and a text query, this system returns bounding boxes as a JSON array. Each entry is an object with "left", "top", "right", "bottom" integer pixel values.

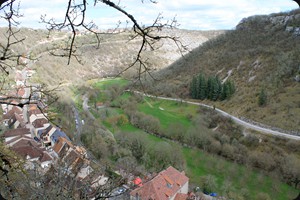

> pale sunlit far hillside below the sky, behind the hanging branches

[{"left": 0, "top": 28, "right": 224, "bottom": 85}]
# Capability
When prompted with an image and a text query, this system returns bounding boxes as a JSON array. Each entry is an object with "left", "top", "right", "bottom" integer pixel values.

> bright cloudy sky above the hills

[{"left": 0, "top": 0, "right": 298, "bottom": 30}]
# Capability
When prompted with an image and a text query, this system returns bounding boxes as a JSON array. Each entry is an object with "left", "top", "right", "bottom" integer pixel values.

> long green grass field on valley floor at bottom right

[{"left": 182, "top": 148, "right": 299, "bottom": 200}]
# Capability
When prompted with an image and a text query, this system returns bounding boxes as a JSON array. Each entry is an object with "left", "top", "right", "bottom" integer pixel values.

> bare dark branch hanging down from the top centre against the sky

[{"left": 41, "top": 0, "right": 186, "bottom": 81}]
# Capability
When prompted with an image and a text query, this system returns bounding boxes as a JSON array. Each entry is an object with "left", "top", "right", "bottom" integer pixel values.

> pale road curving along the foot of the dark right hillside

[{"left": 130, "top": 91, "right": 300, "bottom": 140}]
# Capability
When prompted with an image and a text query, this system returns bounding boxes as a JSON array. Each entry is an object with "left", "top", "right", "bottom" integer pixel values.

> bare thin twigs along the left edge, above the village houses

[{"left": 0, "top": 0, "right": 58, "bottom": 110}]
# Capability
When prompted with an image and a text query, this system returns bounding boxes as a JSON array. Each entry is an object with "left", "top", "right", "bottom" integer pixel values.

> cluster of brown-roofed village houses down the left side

[{"left": 1, "top": 68, "right": 107, "bottom": 192}]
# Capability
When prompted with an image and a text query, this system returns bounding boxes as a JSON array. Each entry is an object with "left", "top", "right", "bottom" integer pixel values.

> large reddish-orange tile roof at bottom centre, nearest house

[{"left": 130, "top": 167, "right": 189, "bottom": 200}]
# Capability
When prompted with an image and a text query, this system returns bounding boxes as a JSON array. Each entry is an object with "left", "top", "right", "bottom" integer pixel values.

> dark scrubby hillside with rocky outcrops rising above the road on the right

[{"left": 148, "top": 10, "right": 300, "bottom": 131}]
